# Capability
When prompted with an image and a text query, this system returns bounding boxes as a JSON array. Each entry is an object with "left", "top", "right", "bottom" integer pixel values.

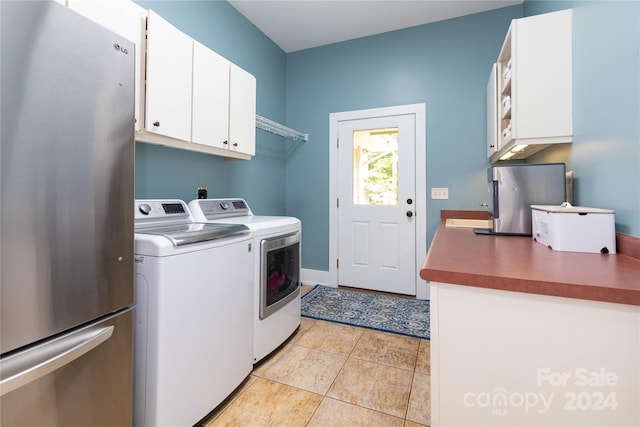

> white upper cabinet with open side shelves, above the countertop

[{"left": 487, "top": 9, "right": 573, "bottom": 162}]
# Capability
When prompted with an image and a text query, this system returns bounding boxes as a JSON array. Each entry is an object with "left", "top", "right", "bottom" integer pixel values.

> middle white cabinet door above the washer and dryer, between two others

[{"left": 191, "top": 41, "right": 229, "bottom": 148}]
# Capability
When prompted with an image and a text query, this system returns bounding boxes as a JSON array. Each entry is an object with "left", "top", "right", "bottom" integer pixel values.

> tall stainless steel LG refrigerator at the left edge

[{"left": 0, "top": 0, "right": 135, "bottom": 427}]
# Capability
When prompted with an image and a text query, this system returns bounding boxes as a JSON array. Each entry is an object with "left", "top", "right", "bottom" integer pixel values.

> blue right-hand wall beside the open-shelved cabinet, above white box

[{"left": 525, "top": 1, "right": 640, "bottom": 236}]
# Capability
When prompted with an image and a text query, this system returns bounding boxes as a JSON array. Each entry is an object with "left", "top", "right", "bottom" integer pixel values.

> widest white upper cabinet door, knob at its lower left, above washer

[{"left": 145, "top": 10, "right": 193, "bottom": 141}]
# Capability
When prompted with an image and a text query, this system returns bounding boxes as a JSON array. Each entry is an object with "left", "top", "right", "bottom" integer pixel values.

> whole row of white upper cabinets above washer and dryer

[{"left": 69, "top": 0, "right": 256, "bottom": 160}]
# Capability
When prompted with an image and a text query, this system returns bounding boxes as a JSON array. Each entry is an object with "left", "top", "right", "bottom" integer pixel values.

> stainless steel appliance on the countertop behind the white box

[{"left": 484, "top": 163, "right": 567, "bottom": 236}]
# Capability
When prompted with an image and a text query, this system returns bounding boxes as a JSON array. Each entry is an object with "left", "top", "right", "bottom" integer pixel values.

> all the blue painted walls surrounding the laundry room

[{"left": 136, "top": 0, "right": 640, "bottom": 270}]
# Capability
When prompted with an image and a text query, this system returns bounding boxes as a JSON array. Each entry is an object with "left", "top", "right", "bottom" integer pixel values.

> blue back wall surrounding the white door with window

[{"left": 286, "top": 6, "right": 523, "bottom": 271}]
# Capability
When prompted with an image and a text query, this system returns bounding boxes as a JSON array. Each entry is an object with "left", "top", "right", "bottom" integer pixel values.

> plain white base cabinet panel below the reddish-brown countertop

[{"left": 431, "top": 282, "right": 640, "bottom": 426}]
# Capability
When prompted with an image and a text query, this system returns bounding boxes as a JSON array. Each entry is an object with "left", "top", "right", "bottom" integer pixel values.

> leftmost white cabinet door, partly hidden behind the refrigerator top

[{"left": 68, "top": 0, "right": 147, "bottom": 131}]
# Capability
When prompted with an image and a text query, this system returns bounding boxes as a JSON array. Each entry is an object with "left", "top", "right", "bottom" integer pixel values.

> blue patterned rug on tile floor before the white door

[{"left": 302, "top": 285, "right": 430, "bottom": 339}]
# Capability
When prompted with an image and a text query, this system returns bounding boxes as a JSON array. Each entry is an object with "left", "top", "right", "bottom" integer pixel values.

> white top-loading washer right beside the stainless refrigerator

[{"left": 134, "top": 200, "right": 255, "bottom": 426}]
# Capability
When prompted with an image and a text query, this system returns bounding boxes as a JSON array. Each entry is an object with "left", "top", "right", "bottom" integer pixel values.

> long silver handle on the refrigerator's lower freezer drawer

[{"left": 0, "top": 326, "right": 113, "bottom": 396}]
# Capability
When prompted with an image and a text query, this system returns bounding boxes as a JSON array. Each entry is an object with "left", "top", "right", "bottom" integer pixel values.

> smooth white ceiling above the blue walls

[{"left": 229, "top": 0, "right": 523, "bottom": 53}]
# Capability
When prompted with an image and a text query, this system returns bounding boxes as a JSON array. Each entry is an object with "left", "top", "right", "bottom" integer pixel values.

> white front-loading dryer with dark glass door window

[{"left": 189, "top": 199, "right": 302, "bottom": 363}]
